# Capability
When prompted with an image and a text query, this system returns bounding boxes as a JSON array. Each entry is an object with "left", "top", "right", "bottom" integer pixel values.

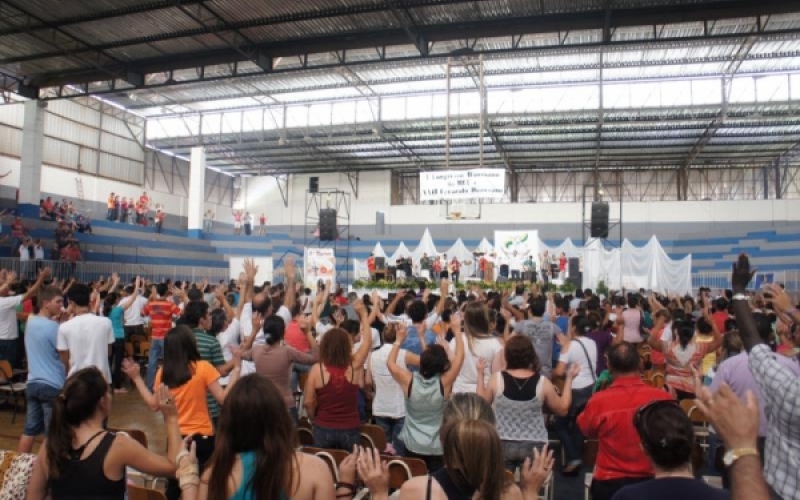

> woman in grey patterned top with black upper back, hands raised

[{"left": 478, "top": 335, "right": 578, "bottom": 472}]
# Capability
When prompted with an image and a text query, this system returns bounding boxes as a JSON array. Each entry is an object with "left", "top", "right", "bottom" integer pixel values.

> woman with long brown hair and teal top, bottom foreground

[{"left": 179, "top": 374, "right": 338, "bottom": 500}]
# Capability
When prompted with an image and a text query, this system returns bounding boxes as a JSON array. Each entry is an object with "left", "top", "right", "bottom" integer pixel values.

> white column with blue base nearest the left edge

[{"left": 17, "top": 101, "right": 46, "bottom": 218}]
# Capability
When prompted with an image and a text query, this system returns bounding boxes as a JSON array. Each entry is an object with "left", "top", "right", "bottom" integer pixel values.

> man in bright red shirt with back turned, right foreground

[{"left": 578, "top": 342, "right": 672, "bottom": 500}]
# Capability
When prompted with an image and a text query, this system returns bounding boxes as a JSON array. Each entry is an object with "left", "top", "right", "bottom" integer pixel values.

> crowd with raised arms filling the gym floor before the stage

[{"left": 0, "top": 256, "right": 800, "bottom": 500}]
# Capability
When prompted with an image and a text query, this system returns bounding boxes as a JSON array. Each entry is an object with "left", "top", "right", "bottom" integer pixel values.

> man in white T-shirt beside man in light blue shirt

[{"left": 56, "top": 284, "right": 114, "bottom": 384}]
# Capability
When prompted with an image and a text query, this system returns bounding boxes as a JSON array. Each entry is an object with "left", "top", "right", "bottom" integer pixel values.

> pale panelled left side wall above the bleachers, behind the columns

[{"left": 0, "top": 100, "right": 232, "bottom": 228}]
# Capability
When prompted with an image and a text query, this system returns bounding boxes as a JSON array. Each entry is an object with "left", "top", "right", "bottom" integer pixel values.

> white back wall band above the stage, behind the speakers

[{"left": 242, "top": 172, "right": 800, "bottom": 242}]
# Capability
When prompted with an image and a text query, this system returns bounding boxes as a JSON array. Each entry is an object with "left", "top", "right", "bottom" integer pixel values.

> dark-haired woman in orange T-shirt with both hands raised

[{"left": 123, "top": 326, "right": 241, "bottom": 500}]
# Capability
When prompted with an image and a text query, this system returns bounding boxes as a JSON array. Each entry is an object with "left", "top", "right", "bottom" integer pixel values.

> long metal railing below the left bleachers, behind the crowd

[{"left": 0, "top": 257, "right": 230, "bottom": 283}]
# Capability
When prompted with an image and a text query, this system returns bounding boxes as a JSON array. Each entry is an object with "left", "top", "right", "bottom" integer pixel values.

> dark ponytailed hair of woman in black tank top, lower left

[{"left": 46, "top": 366, "right": 108, "bottom": 479}]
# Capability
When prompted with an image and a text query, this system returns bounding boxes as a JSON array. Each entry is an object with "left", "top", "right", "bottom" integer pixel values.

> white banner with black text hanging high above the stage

[{"left": 419, "top": 168, "right": 506, "bottom": 201}]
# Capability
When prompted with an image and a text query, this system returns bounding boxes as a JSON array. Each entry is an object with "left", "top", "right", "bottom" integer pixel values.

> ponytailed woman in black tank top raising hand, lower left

[{"left": 25, "top": 367, "right": 181, "bottom": 500}]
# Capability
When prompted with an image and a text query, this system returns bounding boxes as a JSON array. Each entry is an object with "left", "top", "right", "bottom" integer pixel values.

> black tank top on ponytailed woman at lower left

[{"left": 50, "top": 432, "right": 126, "bottom": 500}]
